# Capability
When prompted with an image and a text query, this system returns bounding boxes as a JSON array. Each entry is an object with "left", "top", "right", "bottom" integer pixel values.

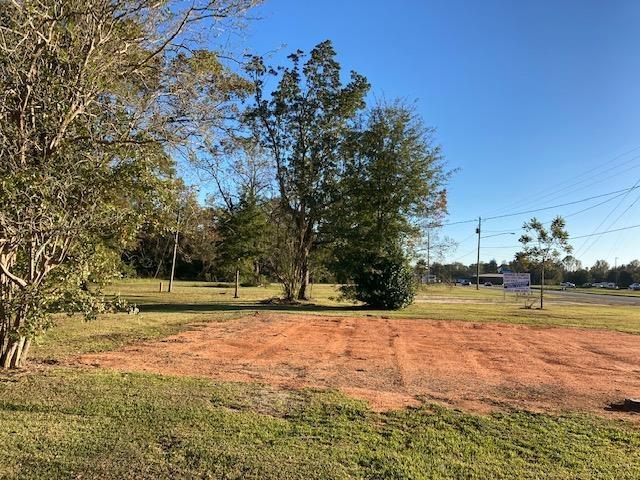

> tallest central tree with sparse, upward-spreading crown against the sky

[{"left": 248, "top": 41, "right": 369, "bottom": 299}]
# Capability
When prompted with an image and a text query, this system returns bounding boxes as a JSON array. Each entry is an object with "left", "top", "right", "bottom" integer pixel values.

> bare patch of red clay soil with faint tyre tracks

[{"left": 79, "top": 314, "right": 640, "bottom": 413}]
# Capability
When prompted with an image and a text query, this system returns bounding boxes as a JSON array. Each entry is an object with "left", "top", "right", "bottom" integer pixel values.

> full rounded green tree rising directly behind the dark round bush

[{"left": 323, "top": 102, "right": 447, "bottom": 304}]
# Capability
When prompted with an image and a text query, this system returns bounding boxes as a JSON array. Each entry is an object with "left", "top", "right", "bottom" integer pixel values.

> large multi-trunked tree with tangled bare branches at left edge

[{"left": 0, "top": 0, "right": 260, "bottom": 368}]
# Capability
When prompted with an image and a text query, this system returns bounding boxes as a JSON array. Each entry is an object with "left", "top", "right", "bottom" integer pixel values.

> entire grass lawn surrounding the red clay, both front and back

[{"left": 0, "top": 281, "right": 640, "bottom": 480}]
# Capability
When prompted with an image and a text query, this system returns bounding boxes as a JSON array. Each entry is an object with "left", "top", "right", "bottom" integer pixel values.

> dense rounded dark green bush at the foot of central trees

[{"left": 342, "top": 249, "right": 416, "bottom": 310}]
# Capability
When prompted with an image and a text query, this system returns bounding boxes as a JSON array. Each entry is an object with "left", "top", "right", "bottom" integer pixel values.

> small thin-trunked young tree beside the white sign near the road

[{"left": 516, "top": 217, "right": 572, "bottom": 309}]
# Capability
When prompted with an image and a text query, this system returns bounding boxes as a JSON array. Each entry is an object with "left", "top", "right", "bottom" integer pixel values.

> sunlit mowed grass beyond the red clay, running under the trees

[{"left": 32, "top": 280, "right": 640, "bottom": 362}]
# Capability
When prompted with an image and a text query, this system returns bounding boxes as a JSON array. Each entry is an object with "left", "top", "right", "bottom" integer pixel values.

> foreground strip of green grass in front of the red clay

[{"left": 0, "top": 368, "right": 640, "bottom": 479}]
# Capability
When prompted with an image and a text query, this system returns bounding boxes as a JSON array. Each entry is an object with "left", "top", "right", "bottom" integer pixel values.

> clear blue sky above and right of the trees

[{"left": 235, "top": 0, "right": 640, "bottom": 265}]
